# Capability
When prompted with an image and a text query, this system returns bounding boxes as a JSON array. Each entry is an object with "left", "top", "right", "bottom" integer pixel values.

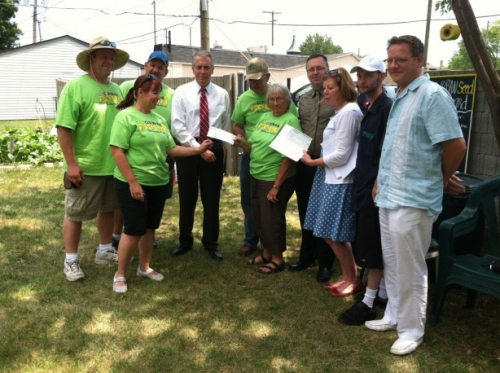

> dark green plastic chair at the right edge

[{"left": 431, "top": 175, "right": 500, "bottom": 324}]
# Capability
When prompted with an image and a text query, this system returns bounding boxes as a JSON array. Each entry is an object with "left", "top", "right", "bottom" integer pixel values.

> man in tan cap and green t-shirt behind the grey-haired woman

[{"left": 231, "top": 57, "right": 298, "bottom": 256}]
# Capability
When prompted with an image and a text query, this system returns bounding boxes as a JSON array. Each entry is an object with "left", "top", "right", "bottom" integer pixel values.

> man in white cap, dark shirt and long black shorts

[{"left": 339, "top": 56, "right": 392, "bottom": 325}]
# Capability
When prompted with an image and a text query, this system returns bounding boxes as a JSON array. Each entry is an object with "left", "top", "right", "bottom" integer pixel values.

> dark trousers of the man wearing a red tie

[{"left": 176, "top": 140, "right": 224, "bottom": 250}]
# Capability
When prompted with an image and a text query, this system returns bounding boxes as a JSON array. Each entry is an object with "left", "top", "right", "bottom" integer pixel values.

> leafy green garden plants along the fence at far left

[{"left": 0, "top": 128, "right": 63, "bottom": 165}]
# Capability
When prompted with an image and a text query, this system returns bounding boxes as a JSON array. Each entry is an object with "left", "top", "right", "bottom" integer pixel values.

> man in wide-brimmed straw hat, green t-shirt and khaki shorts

[{"left": 56, "top": 37, "right": 129, "bottom": 281}]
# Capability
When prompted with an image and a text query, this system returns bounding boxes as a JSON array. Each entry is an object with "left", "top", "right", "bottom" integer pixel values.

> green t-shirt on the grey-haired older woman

[{"left": 248, "top": 112, "right": 302, "bottom": 181}]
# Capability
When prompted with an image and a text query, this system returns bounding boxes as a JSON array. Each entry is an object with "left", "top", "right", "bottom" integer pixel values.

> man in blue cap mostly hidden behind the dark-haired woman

[{"left": 113, "top": 51, "right": 175, "bottom": 247}]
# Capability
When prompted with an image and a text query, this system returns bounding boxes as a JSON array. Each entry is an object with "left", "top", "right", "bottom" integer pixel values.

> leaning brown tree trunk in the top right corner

[{"left": 436, "top": 0, "right": 500, "bottom": 149}]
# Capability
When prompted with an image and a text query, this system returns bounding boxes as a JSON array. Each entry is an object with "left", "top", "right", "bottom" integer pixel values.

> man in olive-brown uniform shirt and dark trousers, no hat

[{"left": 288, "top": 54, "right": 335, "bottom": 282}]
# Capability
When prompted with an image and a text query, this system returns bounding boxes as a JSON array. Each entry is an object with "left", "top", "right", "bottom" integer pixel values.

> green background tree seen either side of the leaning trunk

[{"left": 448, "top": 21, "right": 500, "bottom": 70}]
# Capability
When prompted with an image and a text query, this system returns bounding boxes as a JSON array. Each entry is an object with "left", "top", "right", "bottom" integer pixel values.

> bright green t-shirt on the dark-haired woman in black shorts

[{"left": 109, "top": 106, "right": 175, "bottom": 186}]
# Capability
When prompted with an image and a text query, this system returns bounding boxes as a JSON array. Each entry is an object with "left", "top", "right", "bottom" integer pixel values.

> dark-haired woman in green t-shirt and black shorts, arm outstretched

[{"left": 110, "top": 74, "right": 212, "bottom": 293}]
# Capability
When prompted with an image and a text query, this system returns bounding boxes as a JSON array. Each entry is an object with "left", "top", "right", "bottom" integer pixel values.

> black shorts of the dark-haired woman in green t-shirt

[{"left": 114, "top": 178, "right": 168, "bottom": 236}]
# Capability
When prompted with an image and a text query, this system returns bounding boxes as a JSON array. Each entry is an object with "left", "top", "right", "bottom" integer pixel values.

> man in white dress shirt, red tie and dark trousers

[{"left": 172, "top": 50, "right": 231, "bottom": 260}]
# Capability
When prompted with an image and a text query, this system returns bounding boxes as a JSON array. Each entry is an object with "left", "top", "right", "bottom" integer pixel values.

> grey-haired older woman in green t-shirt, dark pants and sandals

[{"left": 235, "top": 84, "right": 301, "bottom": 274}]
